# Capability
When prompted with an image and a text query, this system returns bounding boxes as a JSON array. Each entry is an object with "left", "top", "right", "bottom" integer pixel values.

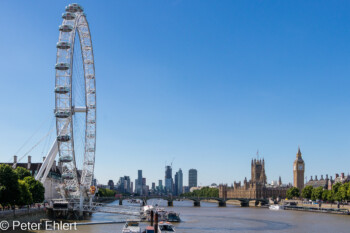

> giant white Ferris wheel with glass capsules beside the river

[{"left": 55, "top": 4, "right": 96, "bottom": 198}]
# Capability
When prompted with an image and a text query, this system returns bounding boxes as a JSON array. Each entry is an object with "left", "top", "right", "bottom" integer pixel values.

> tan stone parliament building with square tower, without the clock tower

[{"left": 219, "top": 159, "right": 289, "bottom": 199}]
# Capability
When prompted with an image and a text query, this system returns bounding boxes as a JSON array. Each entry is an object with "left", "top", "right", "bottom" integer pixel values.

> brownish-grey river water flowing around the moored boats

[{"left": 40, "top": 200, "right": 350, "bottom": 233}]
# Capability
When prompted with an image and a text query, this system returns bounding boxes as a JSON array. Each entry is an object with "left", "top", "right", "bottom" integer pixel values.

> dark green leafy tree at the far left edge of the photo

[{"left": 0, "top": 164, "right": 20, "bottom": 207}]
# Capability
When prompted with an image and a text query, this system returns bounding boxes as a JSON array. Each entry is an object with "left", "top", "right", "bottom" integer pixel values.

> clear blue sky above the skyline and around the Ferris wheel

[{"left": 0, "top": 0, "right": 350, "bottom": 185}]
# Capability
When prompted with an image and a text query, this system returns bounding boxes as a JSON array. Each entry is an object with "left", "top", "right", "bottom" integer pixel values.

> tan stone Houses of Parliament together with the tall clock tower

[{"left": 219, "top": 148, "right": 305, "bottom": 200}]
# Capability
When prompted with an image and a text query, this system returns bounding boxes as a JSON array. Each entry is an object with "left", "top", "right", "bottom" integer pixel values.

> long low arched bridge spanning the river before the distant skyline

[{"left": 96, "top": 195, "right": 269, "bottom": 207}]
